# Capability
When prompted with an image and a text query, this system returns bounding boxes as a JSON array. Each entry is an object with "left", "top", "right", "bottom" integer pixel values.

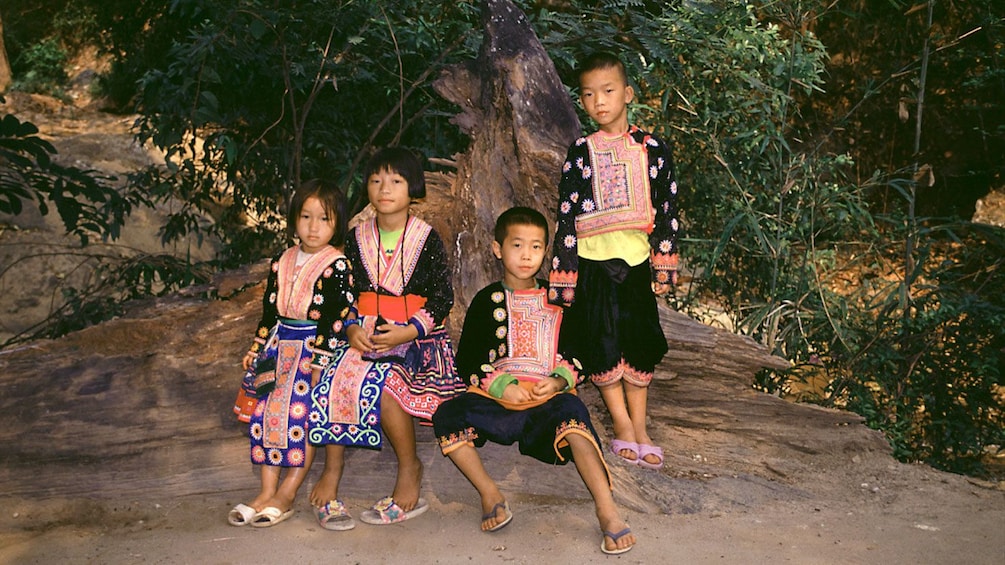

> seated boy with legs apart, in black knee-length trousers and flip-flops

[{"left": 433, "top": 207, "right": 635, "bottom": 554}]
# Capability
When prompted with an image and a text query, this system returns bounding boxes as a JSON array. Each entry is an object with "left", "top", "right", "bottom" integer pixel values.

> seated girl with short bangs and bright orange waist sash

[{"left": 311, "top": 147, "right": 464, "bottom": 530}]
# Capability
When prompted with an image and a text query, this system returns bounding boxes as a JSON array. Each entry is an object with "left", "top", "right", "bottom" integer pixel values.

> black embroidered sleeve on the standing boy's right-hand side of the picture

[{"left": 633, "top": 131, "right": 680, "bottom": 285}]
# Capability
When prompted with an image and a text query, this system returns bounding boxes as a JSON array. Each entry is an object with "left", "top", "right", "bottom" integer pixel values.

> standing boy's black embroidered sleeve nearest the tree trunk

[{"left": 548, "top": 138, "right": 593, "bottom": 306}]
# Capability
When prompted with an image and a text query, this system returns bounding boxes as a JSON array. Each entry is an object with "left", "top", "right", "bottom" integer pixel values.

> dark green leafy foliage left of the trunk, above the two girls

[{"left": 132, "top": 0, "right": 477, "bottom": 264}]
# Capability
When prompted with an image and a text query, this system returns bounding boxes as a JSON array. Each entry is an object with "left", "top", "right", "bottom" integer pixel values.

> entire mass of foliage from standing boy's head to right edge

[{"left": 534, "top": 2, "right": 1005, "bottom": 472}]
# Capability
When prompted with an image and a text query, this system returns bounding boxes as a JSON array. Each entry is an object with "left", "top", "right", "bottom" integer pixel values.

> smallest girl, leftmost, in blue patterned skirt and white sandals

[{"left": 227, "top": 180, "right": 355, "bottom": 527}]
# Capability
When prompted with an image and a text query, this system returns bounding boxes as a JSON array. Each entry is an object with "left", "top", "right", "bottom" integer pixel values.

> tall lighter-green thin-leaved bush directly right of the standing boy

[{"left": 637, "top": 3, "right": 844, "bottom": 357}]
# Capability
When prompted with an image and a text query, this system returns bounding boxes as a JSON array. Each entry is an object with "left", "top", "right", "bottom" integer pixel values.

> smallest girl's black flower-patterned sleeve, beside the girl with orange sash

[{"left": 308, "top": 257, "right": 356, "bottom": 369}]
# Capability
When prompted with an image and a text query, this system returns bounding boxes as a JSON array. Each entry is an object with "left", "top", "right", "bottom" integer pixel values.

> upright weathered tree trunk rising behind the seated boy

[{"left": 422, "top": 0, "right": 581, "bottom": 332}]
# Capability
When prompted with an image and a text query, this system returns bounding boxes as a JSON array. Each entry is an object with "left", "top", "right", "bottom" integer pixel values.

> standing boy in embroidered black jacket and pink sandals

[{"left": 549, "top": 52, "right": 678, "bottom": 468}]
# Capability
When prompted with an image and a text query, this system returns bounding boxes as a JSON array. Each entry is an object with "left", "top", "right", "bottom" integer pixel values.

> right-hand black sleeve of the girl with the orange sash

[{"left": 405, "top": 229, "right": 453, "bottom": 338}]
